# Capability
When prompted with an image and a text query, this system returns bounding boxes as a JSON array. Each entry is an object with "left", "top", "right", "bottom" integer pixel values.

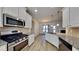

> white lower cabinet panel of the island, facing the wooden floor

[{"left": 45, "top": 33, "right": 59, "bottom": 48}]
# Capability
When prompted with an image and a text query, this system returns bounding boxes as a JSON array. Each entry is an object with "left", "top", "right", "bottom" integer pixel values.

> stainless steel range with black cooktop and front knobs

[{"left": 1, "top": 32, "right": 28, "bottom": 51}]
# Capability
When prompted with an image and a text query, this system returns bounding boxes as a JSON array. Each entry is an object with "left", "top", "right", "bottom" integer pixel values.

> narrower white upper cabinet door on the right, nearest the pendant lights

[{"left": 62, "top": 8, "right": 69, "bottom": 27}]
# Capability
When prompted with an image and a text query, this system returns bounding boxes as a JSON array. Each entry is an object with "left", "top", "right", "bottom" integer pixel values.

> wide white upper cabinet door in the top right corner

[{"left": 70, "top": 7, "right": 79, "bottom": 27}]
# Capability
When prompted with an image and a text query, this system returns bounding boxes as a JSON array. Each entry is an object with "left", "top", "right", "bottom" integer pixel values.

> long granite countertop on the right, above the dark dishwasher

[{"left": 56, "top": 33, "right": 79, "bottom": 49}]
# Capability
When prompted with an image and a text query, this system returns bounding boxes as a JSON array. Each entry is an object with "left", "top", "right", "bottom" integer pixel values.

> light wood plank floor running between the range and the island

[{"left": 22, "top": 35, "right": 57, "bottom": 51}]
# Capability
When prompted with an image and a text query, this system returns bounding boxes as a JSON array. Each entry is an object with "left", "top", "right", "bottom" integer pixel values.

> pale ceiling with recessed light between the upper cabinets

[{"left": 27, "top": 7, "right": 62, "bottom": 22}]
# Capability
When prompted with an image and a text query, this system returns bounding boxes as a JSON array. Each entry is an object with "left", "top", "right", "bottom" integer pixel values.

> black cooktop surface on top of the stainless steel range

[{"left": 1, "top": 33, "right": 25, "bottom": 43}]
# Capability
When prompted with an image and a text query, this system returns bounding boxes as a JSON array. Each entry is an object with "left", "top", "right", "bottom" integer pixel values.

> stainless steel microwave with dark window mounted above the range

[{"left": 3, "top": 14, "right": 25, "bottom": 27}]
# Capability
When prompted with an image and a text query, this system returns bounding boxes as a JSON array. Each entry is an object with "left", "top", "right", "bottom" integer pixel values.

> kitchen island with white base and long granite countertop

[{"left": 45, "top": 33, "right": 79, "bottom": 51}]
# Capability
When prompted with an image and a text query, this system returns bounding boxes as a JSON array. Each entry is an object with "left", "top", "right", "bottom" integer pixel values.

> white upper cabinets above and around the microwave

[{"left": 0, "top": 7, "right": 32, "bottom": 28}]
